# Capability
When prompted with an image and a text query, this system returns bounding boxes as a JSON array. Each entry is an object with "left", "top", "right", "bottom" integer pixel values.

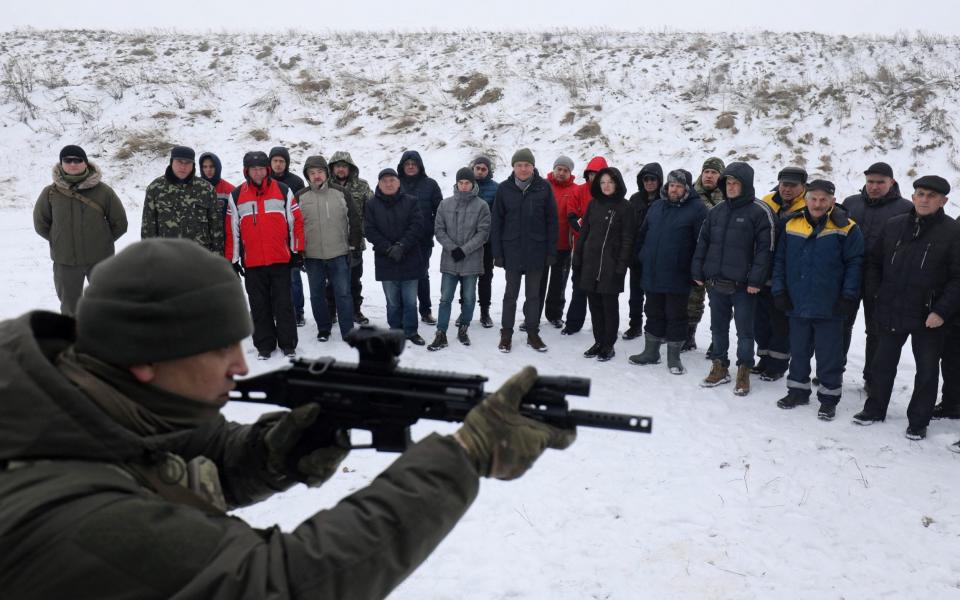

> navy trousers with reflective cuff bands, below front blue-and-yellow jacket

[{"left": 787, "top": 317, "right": 843, "bottom": 406}]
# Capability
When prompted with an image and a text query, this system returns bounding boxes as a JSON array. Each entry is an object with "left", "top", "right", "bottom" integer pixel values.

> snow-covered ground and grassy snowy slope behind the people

[{"left": 0, "top": 27, "right": 960, "bottom": 600}]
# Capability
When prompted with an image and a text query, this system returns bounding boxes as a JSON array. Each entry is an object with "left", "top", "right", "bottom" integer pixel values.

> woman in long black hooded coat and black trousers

[{"left": 573, "top": 168, "right": 636, "bottom": 361}]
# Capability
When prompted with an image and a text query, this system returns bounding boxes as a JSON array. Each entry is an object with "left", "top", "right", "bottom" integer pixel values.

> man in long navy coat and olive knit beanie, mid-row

[{"left": 490, "top": 148, "right": 557, "bottom": 352}]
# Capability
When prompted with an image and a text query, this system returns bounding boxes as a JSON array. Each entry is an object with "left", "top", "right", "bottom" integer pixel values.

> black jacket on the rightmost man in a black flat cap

[{"left": 864, "top": 209, "right": 960, "bottom": 333}]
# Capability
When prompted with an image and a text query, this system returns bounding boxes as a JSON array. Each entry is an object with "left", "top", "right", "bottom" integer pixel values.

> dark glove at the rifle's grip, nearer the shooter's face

[{"left": 261, "top": 404, "right": 349, "bottom": 487}]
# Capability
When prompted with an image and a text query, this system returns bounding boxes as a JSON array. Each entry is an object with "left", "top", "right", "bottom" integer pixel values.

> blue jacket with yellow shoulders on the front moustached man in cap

[{"left": 772, "top": 206, "right": 864, "bottom": 319}]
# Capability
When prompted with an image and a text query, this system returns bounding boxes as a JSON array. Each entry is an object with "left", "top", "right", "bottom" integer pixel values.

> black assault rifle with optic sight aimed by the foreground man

[{"left": 230, "top": 325, "right": 652, "bottom": 452}]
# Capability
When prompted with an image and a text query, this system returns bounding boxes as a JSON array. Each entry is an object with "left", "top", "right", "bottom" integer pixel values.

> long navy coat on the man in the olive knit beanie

[{"left": 490, "top": 169, "right": 558, "bottom": 272}]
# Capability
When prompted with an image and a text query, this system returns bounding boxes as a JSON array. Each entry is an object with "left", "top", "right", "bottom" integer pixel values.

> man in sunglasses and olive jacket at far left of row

[{"left": 33, "top": 146, "right": 127, "bottom": 316}]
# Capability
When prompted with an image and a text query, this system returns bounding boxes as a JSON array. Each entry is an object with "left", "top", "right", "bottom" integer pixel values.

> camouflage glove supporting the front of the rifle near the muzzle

[{"left": 454, "top": 367, "right": 577, "bottom": 479}]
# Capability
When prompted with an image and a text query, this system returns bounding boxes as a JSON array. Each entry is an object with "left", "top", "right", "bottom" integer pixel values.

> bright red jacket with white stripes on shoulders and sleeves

[{"left": 226, "top": 169, "right": 303, "bottom": 268}]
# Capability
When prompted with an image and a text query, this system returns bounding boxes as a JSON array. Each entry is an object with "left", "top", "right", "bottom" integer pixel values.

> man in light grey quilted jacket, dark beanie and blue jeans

[{"left": 427, "top": 167, "right": 490, "bottom": 350}]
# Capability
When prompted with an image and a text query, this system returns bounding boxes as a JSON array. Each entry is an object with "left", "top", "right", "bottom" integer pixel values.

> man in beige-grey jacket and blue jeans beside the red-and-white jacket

[{"left": 297, "top": 156, "right": 362, "bottom": 342}]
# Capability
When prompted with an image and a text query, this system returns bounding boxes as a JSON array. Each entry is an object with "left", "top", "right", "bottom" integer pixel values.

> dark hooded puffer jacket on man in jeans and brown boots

[{"left": 691, "top": 162, "right": 774, "bottom": 288}]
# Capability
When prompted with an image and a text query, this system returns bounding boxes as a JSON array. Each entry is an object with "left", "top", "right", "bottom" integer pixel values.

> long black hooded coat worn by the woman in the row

[{"left": 573, "top": 167, "right": 637, "bottom": 294}]
